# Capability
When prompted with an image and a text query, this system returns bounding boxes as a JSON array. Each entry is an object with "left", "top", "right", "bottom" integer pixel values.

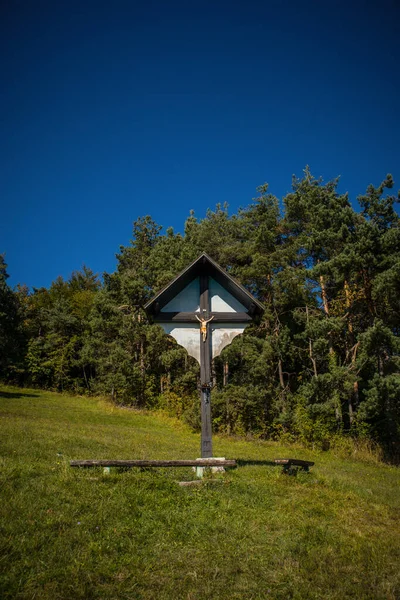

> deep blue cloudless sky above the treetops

[{"left": 0, "top": 0, "right": 400, "bottom": 287}]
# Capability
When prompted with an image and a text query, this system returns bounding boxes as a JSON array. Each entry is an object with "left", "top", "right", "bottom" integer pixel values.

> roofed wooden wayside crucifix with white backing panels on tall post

[{"left": 145, "top": 253, "right": 264, "bottom": 458}]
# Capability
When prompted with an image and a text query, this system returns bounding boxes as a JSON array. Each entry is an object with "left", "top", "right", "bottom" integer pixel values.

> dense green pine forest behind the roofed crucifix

[{"left": 0, "top": 167, "right": 400, "bottom": 462}]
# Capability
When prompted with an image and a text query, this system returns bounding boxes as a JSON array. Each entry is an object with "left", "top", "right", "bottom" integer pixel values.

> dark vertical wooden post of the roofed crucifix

[{"left": 199, "top": 275, "right": 212, "bottom": 458}]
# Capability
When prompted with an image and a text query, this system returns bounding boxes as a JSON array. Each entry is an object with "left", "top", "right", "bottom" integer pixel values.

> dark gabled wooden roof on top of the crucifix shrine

[{"left": 144, "top": 252, "right": 264, "bottom": 316}]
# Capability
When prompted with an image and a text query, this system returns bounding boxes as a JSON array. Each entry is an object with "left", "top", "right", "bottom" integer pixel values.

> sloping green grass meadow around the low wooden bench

[{"left": 0, "top": 386, "right": 400, "bottom": 600}]
